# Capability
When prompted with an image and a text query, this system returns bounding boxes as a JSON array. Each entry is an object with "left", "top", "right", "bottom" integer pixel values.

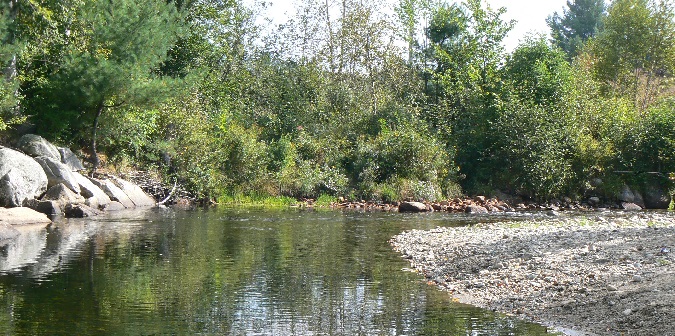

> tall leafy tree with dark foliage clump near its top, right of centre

[{"left": 427, "top": 0, "right": 513, "bottom": 188}]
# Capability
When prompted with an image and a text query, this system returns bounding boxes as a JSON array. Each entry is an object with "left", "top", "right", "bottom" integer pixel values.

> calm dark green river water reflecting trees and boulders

[{"left": 0, "top": 209, "right": 560, "bottom": 335}]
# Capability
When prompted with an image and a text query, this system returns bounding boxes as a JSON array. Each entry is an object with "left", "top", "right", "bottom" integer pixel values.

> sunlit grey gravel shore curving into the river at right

[{"left": 391, "top": 213, "right": 675, "bottom": 335}]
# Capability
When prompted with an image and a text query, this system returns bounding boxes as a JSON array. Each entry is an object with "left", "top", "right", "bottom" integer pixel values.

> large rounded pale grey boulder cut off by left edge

[{"left": 0, "top": 148, "right": 48, "bottom": 207}]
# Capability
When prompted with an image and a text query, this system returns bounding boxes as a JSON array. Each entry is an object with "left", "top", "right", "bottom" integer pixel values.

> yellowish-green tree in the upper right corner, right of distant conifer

[{"left": 589, "top": 0, "right": 675, "bottom": 112}]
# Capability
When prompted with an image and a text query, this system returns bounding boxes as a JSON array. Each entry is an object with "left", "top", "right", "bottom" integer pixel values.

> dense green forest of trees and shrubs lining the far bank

[{"left": 0, "top": 0, "right": 675, "bottom": 201}]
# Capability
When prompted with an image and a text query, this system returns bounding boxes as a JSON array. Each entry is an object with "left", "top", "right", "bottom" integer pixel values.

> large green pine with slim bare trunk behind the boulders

[{"left": 33, "top": 0, "right": 179, "bottom": 170}]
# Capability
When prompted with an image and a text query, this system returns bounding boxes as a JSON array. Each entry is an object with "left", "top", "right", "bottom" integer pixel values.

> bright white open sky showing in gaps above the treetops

[{"left": 244, "top": 0, "right": 567, "bottom": 51}]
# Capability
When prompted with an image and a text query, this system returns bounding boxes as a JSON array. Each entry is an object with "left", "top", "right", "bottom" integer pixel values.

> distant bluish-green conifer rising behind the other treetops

[{"left": 546, "top": 0, "right": 606, "bottom": 58}]
